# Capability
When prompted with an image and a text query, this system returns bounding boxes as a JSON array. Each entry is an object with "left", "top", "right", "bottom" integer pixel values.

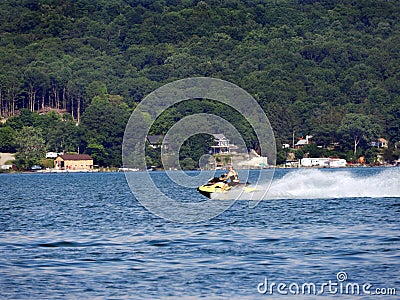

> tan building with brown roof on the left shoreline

[{"left": 54, "top": 154, "right": 93, "bottom": 171}]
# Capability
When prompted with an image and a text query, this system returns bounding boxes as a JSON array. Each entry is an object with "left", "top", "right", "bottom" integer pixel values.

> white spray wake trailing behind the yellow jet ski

[{"left": 214, "top": 168, "right": 400, "bottom": 200}]
